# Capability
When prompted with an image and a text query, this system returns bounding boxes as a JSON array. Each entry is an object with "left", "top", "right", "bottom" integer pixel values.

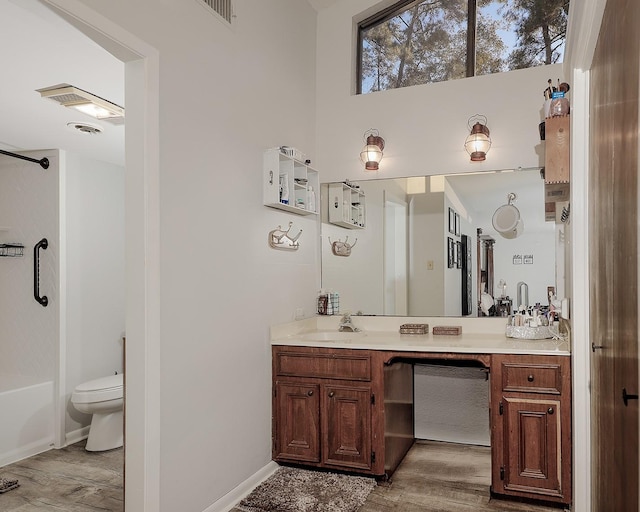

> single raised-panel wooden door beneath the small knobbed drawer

[{"left": 501, "top": 397, "right": 562, "bottom": 497}]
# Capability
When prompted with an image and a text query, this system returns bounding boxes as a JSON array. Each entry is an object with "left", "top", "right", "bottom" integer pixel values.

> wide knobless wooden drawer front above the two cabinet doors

[{"left": 274, "top": 349, "right": 371, "bottom": 381}]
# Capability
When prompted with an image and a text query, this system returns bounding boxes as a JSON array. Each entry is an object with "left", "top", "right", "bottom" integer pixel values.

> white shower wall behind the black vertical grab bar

[{"left": 0, "top": 151, "right": 60, "bottom": 382}]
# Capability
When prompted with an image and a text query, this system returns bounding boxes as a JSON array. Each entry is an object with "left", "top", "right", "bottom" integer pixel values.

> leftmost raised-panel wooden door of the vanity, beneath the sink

[{"left": 273, "top": 382, "right": 320, "bottom": 462}]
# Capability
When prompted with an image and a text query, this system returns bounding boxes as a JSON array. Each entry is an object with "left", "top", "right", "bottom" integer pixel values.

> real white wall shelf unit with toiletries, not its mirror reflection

[{"left": 263, "top": 148, "right": 320, "bottom": 215}]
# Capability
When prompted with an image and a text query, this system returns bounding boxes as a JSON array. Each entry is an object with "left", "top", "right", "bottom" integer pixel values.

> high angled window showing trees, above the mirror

[{"left": 357, "top": 0, "right": 569, "bottom": 94}]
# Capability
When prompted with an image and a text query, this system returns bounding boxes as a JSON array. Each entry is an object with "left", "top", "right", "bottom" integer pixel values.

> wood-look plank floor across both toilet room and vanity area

[{"left": 0, "top": 441, "right": 558, "bottom": 512}]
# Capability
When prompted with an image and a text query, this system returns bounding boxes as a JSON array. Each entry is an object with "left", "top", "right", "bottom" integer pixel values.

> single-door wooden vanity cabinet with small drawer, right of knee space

[{"left": 491, "top": 354, "right": 571, "bottom": 504}]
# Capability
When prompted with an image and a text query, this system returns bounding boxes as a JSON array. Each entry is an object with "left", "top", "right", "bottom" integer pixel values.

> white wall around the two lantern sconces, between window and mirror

[{"left": 317, "top": 0, "right": 563, "bottom": 181}]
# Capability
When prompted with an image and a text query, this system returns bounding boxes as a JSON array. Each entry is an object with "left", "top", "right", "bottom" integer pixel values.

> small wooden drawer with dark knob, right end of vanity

[{"left": 502, "top": 362, "right": 562, "bottom": 395}]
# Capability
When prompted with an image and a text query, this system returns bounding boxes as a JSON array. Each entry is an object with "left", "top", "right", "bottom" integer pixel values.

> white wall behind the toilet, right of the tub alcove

[{"left": 61, "top": 153, "right": 125, "bottom": 434}]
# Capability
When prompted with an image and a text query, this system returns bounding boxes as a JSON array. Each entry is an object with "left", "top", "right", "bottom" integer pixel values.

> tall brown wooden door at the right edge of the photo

[{"left": 592, "top": 0, "right": 640, "bottom": 511}]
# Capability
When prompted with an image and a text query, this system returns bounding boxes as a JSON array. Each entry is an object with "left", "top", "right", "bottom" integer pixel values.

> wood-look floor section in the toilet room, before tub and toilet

[{"left": 0, "top": 441, "right": 124, "bottom": 512}]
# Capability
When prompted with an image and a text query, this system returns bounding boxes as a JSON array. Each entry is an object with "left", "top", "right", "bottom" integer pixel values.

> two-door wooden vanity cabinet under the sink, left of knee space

[{"left": 272, "top": 346, "right": 375, "bottom": 474}]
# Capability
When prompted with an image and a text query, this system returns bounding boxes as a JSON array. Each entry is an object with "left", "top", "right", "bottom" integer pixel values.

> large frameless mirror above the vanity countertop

[{"left": 321, "top": 169, "right": 564, "bottom": 316}]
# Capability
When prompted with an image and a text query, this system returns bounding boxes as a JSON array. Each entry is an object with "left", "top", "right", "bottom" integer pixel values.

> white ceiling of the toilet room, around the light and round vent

[{"left": 0, "top": 0, "right": 126, "bottom": 165}]
